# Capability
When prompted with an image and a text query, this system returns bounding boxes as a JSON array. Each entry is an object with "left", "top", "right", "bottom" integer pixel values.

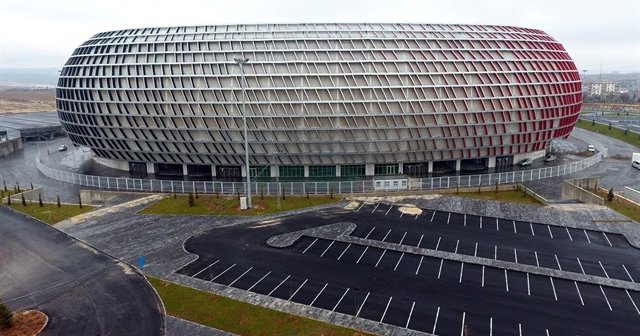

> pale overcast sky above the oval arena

[{"left": 0, "top": 0, "right": 640, "bottom": 74}]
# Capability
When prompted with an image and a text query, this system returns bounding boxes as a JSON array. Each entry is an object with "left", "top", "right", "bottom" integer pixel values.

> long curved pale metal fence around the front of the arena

[{"left": 36, "top": 153, "right": 603, "bottom": 195}]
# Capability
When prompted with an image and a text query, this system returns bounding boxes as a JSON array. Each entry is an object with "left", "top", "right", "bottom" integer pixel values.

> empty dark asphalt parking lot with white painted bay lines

[{"left": 178, "top": 204, "right": 640, "bottom": 335}]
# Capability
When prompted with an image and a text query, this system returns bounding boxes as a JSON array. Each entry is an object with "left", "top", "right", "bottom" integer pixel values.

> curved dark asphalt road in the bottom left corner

[{"left": 0, "top": 206, "right": 164, "bottom": 336}]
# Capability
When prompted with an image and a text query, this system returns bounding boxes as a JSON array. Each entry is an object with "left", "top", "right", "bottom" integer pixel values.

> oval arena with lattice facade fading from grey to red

[{"left": 56, "top": 23, "right": 582, "bottom": 178}]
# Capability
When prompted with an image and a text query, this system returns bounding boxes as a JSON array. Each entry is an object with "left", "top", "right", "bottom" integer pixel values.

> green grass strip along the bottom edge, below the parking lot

[{"left": 147, "top": 277, "right": 368, "bottom": 336}]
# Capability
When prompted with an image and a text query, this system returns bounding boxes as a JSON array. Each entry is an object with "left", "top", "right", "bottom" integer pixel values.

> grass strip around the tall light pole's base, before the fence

[{"left": 139, "top": 195, "right": 341, "bottom": 216}]
